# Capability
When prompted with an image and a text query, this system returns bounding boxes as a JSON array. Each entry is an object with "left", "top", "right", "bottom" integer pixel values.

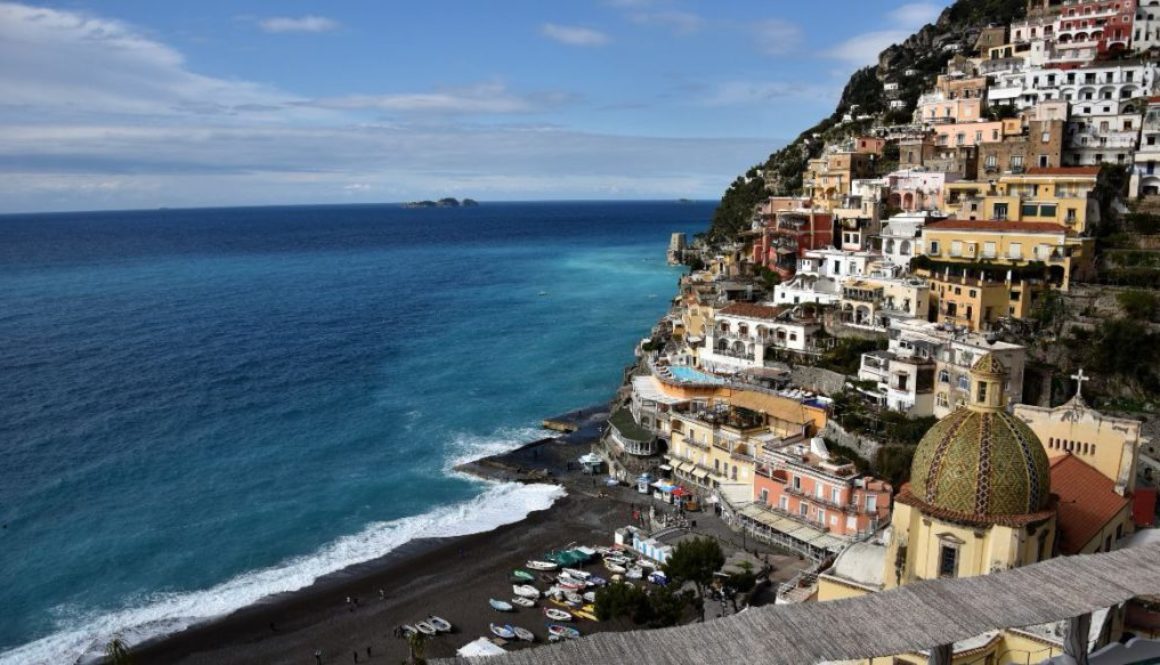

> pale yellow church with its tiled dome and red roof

[{"left": 818, "top": 354, "right": 1130, "bottom": 665}]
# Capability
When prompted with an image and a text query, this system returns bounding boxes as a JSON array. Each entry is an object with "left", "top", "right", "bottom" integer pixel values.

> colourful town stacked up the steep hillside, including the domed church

[{"left": 596, "top": 0, "right": 1160, "bottom": 664}]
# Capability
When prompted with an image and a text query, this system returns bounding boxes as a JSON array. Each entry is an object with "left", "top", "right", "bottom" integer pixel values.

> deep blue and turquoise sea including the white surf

[{"left": 0, "top": 203, "right": 712, "bottom": 665}]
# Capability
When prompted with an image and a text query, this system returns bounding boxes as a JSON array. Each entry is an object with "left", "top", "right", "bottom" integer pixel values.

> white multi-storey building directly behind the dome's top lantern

[{"left": 858, "top": 318, "right": 1027, "bottom": 418}]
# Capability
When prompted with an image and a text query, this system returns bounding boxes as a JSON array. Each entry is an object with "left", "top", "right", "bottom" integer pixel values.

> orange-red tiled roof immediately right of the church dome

[{"left": 1051, "top": 453, "right": 1129, "bottom": 555}]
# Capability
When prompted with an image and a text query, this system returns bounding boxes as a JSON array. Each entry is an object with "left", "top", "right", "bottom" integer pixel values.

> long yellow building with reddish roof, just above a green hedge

[{"left": 922, "top": 219, "right": 1095, "bottom": 290}]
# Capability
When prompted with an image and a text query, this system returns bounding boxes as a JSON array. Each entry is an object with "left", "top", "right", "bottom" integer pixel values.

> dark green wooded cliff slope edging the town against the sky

[{"left": 709, "top": 0, "right": 1027, "bottom": 241}]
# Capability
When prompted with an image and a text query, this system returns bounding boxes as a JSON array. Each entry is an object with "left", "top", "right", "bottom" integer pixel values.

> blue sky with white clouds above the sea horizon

[{"left": 0, "top": 0, "right": 949, "bottom": 212}]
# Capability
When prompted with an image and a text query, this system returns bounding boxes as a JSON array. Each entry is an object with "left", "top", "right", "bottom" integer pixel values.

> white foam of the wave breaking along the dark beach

[{"left": 0, "top": 480, "right": 565, "bottom": 665}]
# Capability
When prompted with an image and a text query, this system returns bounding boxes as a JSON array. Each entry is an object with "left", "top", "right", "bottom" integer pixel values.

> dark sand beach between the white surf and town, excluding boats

[{"left": 125, "top": 422, "right": 628, "bottom": 665}]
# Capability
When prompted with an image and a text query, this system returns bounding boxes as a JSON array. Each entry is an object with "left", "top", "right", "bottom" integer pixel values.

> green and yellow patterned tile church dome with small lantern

[{"left": 909, "top": 353, "right": 1051, "bottom": 522}]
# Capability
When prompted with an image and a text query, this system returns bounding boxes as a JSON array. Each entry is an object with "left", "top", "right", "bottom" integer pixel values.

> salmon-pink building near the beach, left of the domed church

[{"left": 754, "top": 439, "right": 893, "bottom": 538}]
